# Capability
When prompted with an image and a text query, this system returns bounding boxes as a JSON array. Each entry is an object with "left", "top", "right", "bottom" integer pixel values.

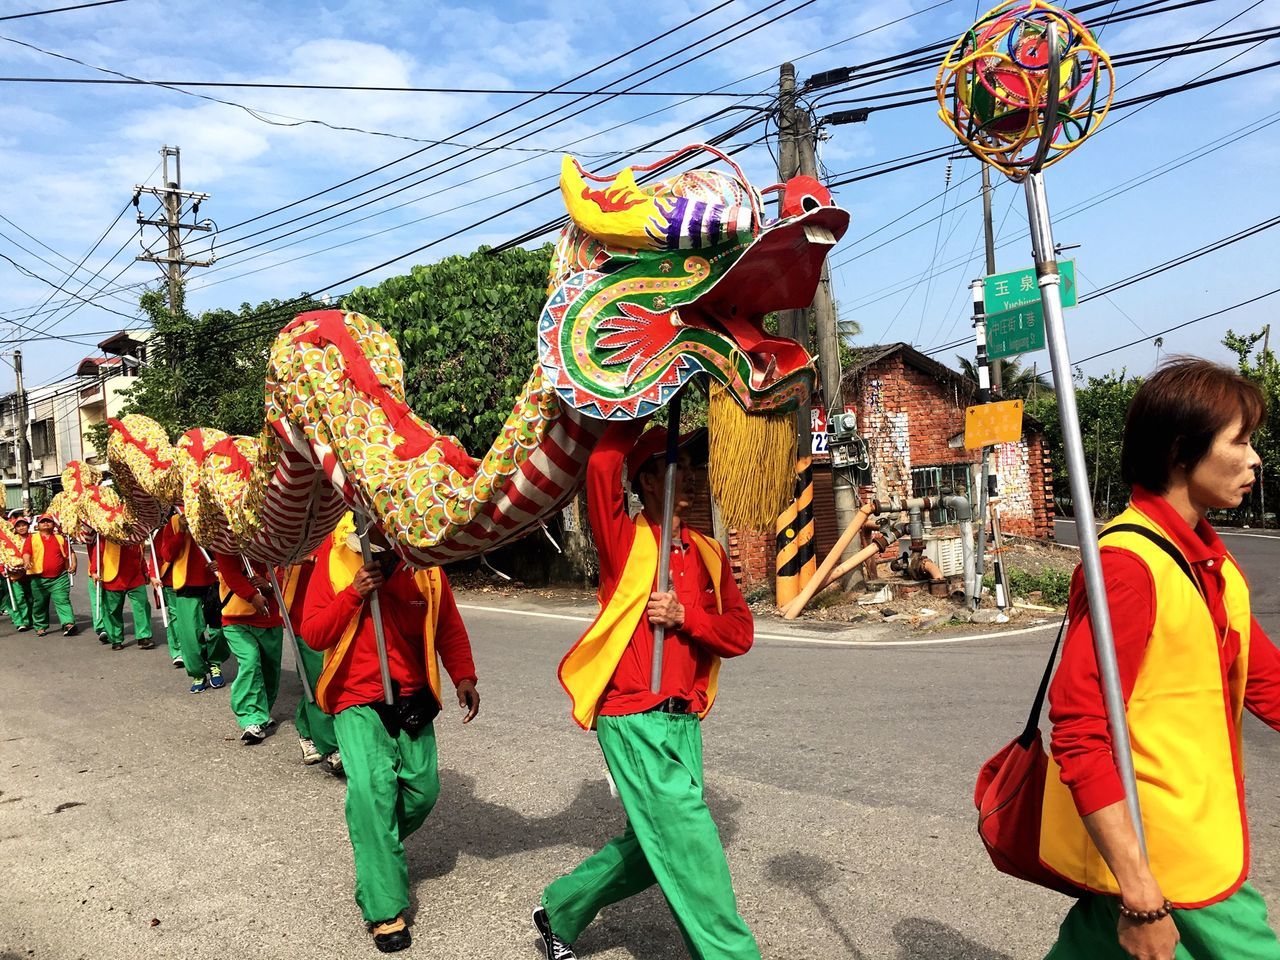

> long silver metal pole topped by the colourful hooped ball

[{"left": 1024, "top": 168, "right": 1147, "bottom": 856}]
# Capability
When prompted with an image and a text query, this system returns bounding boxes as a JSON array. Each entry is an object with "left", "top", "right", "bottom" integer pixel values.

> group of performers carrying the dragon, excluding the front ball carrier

[{"left": 3, "top": 422, "right": 760, "bottom": 960}]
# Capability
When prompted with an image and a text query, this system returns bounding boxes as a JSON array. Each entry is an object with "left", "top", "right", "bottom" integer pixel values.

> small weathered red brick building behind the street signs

[{"left": 728, "top": 343, "right": 1053, "bottom": 584}]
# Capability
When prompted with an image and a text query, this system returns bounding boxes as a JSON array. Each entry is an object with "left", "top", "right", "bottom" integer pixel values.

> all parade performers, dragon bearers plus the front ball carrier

[{"left": 4, "top": 358, "right": 1280, "bottom": 960}]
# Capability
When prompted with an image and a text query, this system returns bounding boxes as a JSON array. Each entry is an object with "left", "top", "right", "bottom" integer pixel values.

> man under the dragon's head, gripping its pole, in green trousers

[{"left": 534, "top": 421, "right": 760, "bottom": 960}]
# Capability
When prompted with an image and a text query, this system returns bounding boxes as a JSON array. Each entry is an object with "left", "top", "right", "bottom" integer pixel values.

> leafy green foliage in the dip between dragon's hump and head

[{"left": 343, "top": 244, "right": 552, "bottom": 456}]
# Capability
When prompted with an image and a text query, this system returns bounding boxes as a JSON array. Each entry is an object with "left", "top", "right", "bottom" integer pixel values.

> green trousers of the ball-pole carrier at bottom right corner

[{"left": 1044, "top": 883, "right": 1280, "bottom": 960}]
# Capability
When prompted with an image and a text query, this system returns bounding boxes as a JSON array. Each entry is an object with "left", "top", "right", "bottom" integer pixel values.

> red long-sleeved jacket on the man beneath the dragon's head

[{"left": 586, "top": 421, "right": 755, "bottom": 717}]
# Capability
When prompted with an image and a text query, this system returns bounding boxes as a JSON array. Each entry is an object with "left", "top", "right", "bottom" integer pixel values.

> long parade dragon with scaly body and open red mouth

[{"left": 57, "top": 147, "right": 849, "bottom": 566}]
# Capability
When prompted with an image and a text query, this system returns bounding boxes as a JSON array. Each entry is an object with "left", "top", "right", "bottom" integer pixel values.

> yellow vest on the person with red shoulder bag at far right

[{"left": 1039, "top": 506, "right": 1251, "bottom": 908}]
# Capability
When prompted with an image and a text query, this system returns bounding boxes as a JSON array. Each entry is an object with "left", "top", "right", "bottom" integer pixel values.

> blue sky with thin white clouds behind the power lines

[{"left": 0, "top": 0, "right": 1280, "bottom": 384}]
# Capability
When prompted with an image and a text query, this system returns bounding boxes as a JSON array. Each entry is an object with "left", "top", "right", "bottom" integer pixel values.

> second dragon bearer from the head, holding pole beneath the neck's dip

[{"left": 302, "top": 515, "right": 480, "bottom": 952}]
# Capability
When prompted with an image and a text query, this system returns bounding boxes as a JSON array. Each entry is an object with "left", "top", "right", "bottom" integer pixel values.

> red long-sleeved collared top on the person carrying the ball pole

[{"left": 1048, "top": 486, "right": 1280, "bottom": 817}]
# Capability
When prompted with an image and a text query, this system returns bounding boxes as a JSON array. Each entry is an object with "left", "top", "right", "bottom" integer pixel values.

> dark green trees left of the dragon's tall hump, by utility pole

[{"left": 87, "top": 291, "right": 324, "bottom": 453}]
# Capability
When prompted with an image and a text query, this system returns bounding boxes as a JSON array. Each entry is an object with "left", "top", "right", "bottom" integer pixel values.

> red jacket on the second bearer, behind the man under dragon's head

[{"left": 301, "top": 539, "right": 476, "bottom": 713}]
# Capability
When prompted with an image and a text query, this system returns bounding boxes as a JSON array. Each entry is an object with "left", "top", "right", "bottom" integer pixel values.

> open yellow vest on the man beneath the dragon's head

[{"left": 559, "top": 522, "right": 724, "bottom": 730}]
